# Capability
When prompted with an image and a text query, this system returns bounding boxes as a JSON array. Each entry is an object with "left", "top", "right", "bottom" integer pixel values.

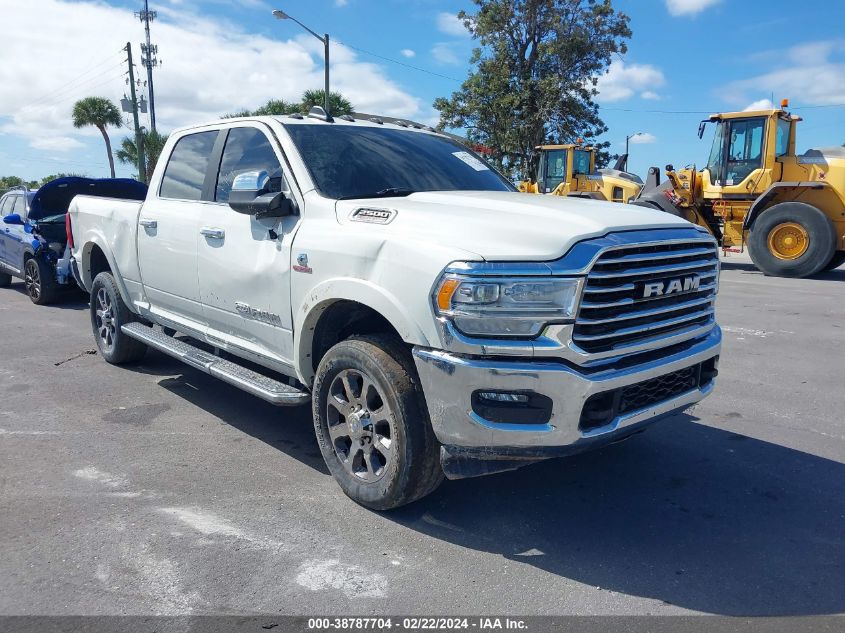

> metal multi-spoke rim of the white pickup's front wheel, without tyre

[{"left": 326, "top": 369, "right": 396, "bottom": 483}]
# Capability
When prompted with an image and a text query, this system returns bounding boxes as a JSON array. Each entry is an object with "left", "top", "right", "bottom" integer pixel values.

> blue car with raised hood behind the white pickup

[{"left": 0, "top": 176, "right": 147, "bottom": 305}]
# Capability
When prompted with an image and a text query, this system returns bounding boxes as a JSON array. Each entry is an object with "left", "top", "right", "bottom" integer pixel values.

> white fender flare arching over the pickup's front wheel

[{"left": 293, "top": 277, "right": 437, "bottom": 385}]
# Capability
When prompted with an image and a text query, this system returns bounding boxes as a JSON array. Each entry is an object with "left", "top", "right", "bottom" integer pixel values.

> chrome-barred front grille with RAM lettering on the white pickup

[{"left": 572, "top": 238, "right": 719, "bottom": 354}]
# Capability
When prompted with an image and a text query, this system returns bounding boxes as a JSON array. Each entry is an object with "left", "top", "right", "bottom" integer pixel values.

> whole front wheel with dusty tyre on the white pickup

[{"left": 313, "top": 336, "right": 443, "bottom": 510}]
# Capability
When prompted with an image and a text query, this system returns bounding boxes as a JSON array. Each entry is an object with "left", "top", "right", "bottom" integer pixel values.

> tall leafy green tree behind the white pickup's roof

[{"left": 434, "top": 0, "right": 631, "bottom": 177}]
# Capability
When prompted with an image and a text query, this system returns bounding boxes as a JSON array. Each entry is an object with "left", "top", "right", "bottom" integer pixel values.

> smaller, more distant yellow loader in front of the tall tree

[{"left": 519, "top": 143, "right": 643, "bottom": 202}]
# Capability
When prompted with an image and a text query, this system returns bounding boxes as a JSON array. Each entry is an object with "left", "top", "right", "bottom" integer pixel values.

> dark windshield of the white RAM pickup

[{"left": 286, "top": 124, "right": 514, "bottom": 199}]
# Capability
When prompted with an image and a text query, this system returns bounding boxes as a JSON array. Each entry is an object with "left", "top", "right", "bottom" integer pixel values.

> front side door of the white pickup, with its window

[{"left": 197, "top": 123, "right": 299, "bottom": 365}]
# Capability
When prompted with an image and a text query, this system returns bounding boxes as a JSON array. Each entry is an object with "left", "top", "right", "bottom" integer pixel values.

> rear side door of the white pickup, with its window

[{"left": 138, "top": 130, "right": 219, "bottom": 330}]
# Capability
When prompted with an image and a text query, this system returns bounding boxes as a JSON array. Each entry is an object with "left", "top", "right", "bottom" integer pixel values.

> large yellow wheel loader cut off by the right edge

[{"left": 634, "top": 99, "right": 845, "bottom": 277}]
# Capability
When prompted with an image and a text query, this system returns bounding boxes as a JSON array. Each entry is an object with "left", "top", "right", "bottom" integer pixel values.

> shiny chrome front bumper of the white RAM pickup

[{"left": 413, "top": 326, "right": 722, "bottom": 456}]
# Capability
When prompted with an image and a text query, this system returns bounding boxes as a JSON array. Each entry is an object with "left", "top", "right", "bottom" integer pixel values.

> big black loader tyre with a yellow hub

[{"left": 748, "top": 202, "right": 836, "bottom": 277}]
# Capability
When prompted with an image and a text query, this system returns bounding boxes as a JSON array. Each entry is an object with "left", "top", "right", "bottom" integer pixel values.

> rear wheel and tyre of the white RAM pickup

[{"left": 91, "top": 273, "right": 147, "bottom": 365}]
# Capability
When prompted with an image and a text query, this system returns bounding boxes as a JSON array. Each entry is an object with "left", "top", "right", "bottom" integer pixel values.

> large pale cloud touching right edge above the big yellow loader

[{"left": 719, "top": 40, "right": 845, "bottom": 105}]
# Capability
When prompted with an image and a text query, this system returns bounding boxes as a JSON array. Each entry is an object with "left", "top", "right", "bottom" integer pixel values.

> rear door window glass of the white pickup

[{"left": 159, "top": 130, "right": 217, "bottom": 200}]
